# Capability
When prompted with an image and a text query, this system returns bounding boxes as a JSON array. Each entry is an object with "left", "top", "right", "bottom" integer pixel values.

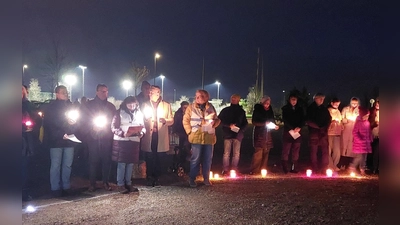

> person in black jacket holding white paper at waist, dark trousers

[{"left": 282, "top": 94, "right": 305, "bottom": 173}]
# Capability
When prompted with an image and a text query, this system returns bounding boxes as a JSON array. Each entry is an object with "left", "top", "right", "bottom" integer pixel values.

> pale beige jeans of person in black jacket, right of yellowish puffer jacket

[{"left": 222, "top": 138, "right": 241, "bottom": 171}]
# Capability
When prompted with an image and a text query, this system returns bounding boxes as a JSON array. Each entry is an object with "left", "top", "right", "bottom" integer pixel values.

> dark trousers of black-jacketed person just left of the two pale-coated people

[{"left": 309, "top": 135, "right": 329, "bottom": 172}]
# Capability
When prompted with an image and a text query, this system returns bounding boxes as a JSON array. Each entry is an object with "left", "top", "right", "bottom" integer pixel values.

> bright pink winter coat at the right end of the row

[{"left": 353, "top": 117, "right": 373, "bottom": 153}]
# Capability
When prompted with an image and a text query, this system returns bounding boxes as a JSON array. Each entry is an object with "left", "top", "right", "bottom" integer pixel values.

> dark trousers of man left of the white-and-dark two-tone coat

[{"left": 88, "top": 140, "right": 112, "bottom": 186}]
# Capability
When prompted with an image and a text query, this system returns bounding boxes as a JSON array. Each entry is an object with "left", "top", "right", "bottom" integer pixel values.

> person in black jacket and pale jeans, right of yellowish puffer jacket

[{"left": 218, "top": 94, "right": 248, "bottom": 175}]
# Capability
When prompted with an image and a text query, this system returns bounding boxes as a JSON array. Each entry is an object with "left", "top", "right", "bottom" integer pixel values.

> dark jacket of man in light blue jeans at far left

[{"left": 43, "top": 99, "right": 77, "bottom": 148}]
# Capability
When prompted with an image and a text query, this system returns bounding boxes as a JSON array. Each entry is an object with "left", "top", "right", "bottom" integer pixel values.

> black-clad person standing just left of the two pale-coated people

[{"left": 306, "top": 93, "right": 332, "bottom": 173}]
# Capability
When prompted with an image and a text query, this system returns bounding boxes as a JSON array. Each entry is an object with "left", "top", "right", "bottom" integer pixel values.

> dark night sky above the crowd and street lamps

[{"left": 23, "top": 0, "right": 379, "bottom": 104}]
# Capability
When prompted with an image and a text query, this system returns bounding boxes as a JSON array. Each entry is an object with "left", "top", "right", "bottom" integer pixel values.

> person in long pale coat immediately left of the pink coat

[{"left": 339, "top": 97, "right": 360, "bottom": 169}]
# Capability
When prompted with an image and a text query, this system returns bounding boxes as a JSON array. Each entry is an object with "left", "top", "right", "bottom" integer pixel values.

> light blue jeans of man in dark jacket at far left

[{"left": 50, "top": 147, "right": 74, "bottom": 191}]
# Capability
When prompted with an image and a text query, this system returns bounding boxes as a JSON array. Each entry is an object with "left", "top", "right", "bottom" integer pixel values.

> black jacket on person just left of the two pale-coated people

[{"left": 307, "top": 102, "right": 332, "bottom": 139}]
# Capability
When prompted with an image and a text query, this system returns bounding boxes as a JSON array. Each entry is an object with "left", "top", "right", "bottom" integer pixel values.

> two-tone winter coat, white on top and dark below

[{"left": 111, "top": 109, "right": 146, "bottom": 163}]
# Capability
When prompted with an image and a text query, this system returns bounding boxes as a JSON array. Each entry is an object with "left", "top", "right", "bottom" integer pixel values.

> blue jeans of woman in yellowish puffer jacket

[{"left": 189, "top": 144, "right": 214, "bottom": 181}]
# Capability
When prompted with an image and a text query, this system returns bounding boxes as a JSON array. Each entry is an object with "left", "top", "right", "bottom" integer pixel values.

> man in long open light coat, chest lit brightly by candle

[{"left": 141, "top": 86, "right": 174, "bottom": 187}]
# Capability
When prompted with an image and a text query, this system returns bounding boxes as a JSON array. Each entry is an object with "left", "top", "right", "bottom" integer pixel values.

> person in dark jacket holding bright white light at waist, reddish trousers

[{"left": 250, "top": 96, "right": 279, "bottom": 174}]
